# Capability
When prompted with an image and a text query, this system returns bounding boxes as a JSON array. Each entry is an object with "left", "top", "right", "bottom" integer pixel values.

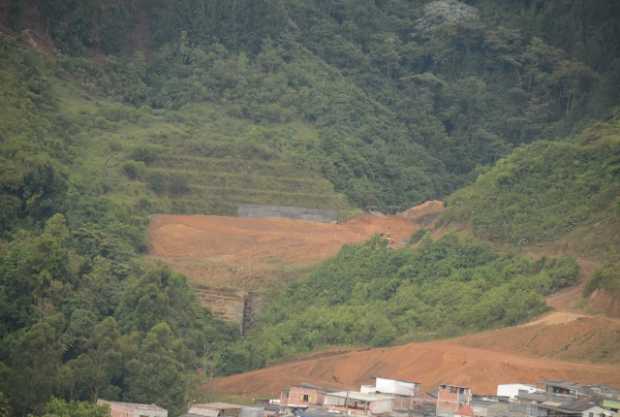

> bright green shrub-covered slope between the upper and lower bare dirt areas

[{"left": 244, "top": 235, "right": 579, "bottom": 365}]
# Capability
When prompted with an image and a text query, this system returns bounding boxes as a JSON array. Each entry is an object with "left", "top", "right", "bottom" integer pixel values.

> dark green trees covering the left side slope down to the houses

[{"left": 0, "top": 36, "right": 236, "bottom": 417}]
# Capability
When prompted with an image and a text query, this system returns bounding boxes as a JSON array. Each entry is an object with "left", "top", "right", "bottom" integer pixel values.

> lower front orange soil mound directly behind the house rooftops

[{"left": 211, "top": 342, "right": 620, "bottom": 397}]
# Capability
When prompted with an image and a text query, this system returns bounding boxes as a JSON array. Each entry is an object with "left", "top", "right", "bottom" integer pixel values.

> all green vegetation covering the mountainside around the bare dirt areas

[{"left": 0, "top": 0, "right": 620, "bottom": 417}]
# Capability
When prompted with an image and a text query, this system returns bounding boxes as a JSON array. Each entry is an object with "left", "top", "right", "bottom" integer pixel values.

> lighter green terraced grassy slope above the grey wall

[{"left": 53, "top": 75, "right": 350, "bottom": 214}]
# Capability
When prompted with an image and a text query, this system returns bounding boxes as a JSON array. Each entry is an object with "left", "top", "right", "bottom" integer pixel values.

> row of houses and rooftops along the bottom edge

[{"left": 95, "top": 378, "right": 620, "bottom": 417}]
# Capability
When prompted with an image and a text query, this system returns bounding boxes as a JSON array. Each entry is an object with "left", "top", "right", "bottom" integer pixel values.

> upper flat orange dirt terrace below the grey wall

[{"left": 149, "top": 202, "right": 443, "bottom": 290}]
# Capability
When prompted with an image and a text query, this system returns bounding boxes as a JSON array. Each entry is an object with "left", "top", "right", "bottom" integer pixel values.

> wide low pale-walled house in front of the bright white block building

[{"left": 323, "top": 391, "right": 394, "bottom": 416}]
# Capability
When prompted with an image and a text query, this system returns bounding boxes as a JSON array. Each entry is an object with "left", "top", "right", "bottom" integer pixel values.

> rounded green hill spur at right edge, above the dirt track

[{"left": 444, "top": 117, "right": 620, "bottom": 259}]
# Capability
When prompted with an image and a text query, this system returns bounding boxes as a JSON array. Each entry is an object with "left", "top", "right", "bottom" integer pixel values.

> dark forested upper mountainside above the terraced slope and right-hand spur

[{"left": 8, "top": 0, "right": 620, "bottom": 211}]
